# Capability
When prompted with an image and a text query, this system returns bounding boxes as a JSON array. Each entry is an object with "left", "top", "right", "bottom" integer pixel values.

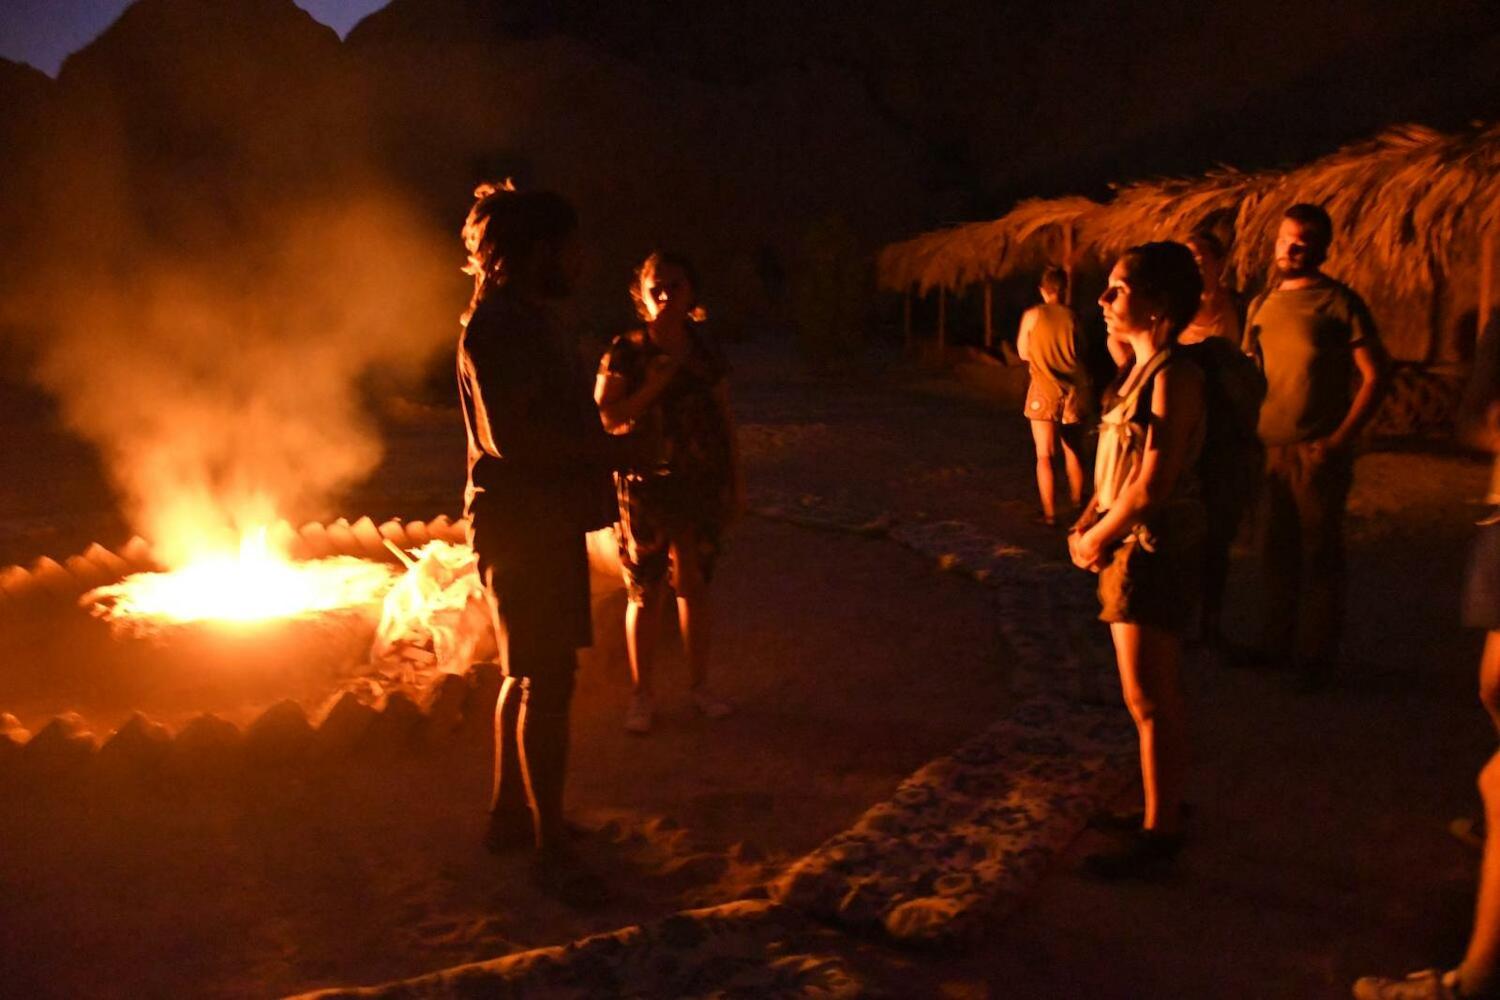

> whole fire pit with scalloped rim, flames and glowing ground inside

[{"left": 0, "top": 517, "right": 486, "bottom": 729}]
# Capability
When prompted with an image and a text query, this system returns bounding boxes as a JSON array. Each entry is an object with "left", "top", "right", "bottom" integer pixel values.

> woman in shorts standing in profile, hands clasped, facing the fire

[{"left": 1068, "top": 243, "right": 1205, "bottom": 879}]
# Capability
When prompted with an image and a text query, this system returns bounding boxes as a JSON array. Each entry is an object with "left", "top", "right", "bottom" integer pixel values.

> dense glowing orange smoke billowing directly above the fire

[{"left": 17, "top": 196, "right": 455, "bottom": 562}]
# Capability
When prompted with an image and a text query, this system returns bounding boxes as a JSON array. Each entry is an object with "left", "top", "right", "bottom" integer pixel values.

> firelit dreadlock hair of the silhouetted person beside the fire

[{"left": 462, "top": 178, "right": 578, "bottom": 325}]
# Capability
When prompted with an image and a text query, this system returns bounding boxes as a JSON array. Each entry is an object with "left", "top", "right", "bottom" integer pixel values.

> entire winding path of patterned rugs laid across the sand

[{"left": 295, "top": 503, "right": 1136, "bottom": 1000}]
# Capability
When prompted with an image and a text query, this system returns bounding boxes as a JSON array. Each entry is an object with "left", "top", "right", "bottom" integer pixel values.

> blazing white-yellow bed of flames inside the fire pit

[{"left": 83, "top": 528, "right": 398, "bottom": 628}]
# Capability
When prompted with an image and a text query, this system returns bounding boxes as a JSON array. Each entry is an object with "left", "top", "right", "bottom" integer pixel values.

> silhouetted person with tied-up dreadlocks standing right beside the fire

[{"left": 458, "top": 184, "right": 614, "bottom": 904}]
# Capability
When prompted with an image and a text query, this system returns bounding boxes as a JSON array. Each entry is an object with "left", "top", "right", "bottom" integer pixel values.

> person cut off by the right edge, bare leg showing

[{"left": 1355, "top": 314, "right": 1500, "bottom": 1000}]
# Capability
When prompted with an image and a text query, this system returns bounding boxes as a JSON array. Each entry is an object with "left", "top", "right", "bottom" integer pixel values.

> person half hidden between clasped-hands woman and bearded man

[{"left": 1178, "top": 232, "right": 1266, "bottom": 652}]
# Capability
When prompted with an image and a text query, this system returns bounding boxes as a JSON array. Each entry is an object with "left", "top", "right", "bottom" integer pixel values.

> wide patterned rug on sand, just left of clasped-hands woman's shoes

[{"left": 771, "top": 697, "right": 1136, "bottom": 943}]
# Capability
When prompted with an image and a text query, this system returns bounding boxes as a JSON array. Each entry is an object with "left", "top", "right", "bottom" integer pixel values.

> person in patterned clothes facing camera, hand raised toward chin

[{"left": 594, "top": 252, "right": 744, "bottom": 735}]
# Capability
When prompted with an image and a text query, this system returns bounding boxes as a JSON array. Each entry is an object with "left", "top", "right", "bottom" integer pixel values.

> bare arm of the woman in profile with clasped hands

[{"left": 1071, "top": 364, "right": 1205, "bottom": 567}]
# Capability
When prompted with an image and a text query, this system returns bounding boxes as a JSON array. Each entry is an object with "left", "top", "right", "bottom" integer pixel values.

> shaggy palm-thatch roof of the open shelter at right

[{"left": 879, "top": 124, "right": 1500, "bottom": 297}]
